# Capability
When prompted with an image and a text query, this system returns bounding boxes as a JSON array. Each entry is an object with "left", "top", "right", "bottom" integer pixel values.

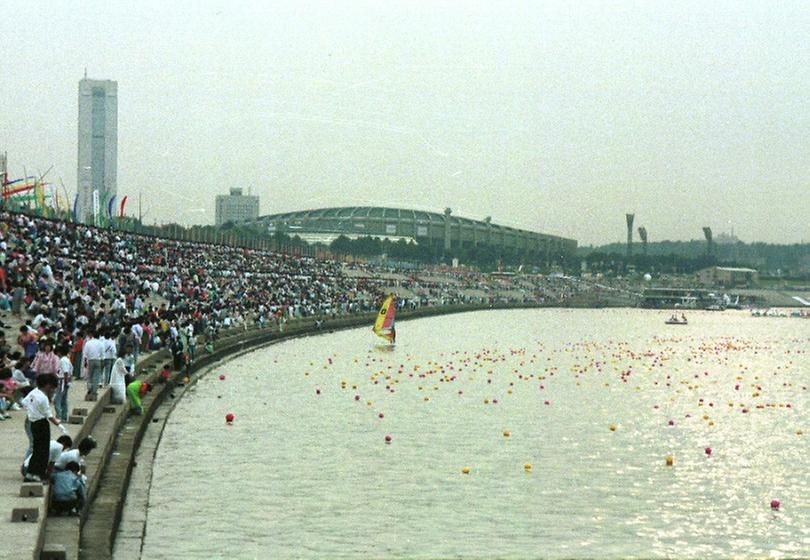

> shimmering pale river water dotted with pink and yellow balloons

[{"left": 136, "top": 309, "right": 810, "bottom": 559}]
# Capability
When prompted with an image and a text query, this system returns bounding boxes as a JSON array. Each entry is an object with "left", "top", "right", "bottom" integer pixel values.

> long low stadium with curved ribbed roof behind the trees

[{"left": 254, "top": 206, "right": 577, "bottom": 262}]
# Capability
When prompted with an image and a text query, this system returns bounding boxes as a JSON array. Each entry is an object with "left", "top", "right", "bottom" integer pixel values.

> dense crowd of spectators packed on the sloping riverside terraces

[{"left": 0, "top": 212, "right": 608, "bottom": 511}]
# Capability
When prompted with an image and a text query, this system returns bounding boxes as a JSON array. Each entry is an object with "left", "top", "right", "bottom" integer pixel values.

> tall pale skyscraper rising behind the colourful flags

[{"left": 76, "top": 75, "right": 118, "bottom": 225}]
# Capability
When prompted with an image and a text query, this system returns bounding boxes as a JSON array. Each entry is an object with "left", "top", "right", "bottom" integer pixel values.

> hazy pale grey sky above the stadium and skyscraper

[{"left": 0, "top": 0, "right": 810, "bottom": 244}]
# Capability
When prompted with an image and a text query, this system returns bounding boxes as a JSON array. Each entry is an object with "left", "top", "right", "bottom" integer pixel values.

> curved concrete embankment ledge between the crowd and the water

[{"left": 80, "top": 304, "right": 548, "bottom": 560}]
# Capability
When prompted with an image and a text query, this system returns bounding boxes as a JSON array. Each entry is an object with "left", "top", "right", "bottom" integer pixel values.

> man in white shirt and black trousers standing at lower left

[{"left": 23, "top": 373, "right": 67, "bottom": 482}]
